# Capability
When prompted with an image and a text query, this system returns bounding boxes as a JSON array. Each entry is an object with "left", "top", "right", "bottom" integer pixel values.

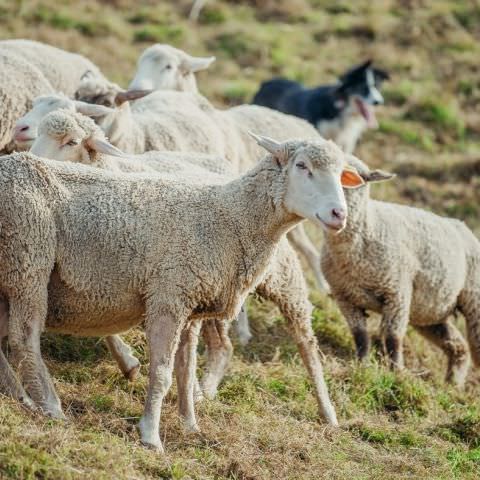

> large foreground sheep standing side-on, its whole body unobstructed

[{"left": 0, "top": 137, "right": 358, "bottom": 451}]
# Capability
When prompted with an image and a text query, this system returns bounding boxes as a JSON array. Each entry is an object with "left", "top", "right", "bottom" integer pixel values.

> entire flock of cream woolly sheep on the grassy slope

[{"left": 0, "top": 35, "right": 480, "bottom": 460}]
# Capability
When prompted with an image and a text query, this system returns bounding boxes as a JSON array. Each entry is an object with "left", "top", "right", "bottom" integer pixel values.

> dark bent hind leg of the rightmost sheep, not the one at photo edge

[{"left": 415, "top": 321, "right": 470, "bottom": 387}]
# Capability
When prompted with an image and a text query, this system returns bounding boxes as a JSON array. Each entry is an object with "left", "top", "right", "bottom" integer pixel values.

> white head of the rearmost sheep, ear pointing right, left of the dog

[{"left": 129, "top": 44, "right": 215, "bottom": 92}]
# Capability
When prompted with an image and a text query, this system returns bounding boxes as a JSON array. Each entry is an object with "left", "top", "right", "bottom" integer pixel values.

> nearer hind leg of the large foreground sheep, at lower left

[{"left": 8, "top": 292, "right": 65, "bottom": 419}]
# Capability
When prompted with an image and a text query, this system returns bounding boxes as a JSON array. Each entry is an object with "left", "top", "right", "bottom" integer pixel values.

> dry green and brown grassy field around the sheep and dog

[{"left": 0, "top": 0, "right": 480, "bottom": 480}]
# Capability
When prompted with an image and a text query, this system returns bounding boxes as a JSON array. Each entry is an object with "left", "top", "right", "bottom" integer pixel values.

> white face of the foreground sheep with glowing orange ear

[{"left": 253, "top": 137, "right": 364, "bottom": 232}]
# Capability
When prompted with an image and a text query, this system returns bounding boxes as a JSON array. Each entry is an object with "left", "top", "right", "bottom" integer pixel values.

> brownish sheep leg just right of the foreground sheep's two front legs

[{"left": 202, "top": 320, "right": 233, "bottom": 399}]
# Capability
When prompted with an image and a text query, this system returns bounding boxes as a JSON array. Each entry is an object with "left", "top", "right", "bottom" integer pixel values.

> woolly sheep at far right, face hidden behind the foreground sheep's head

[{"left": 322, "top": 157, "right": 480, "bottom": 386}]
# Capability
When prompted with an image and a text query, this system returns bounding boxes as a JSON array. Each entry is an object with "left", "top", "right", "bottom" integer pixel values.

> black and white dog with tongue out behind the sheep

[{"left": 253, "top": 60, "right": 389, "bottom": 153}]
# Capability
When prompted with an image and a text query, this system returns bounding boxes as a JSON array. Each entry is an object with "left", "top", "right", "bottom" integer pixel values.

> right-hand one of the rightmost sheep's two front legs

[{"left": 382, "top": 291, "right": 411, "bottom": 370}]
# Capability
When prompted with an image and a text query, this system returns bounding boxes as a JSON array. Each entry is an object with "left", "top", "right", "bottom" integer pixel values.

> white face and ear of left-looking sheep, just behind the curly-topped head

[{"left": 13, "top": 95, "right": 112, "bottom": 150}]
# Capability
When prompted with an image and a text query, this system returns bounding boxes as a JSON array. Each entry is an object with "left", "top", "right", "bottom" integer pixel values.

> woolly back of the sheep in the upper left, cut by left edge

[{"left": 0, "top": 40, "right": 104, "bottom": 153}]
